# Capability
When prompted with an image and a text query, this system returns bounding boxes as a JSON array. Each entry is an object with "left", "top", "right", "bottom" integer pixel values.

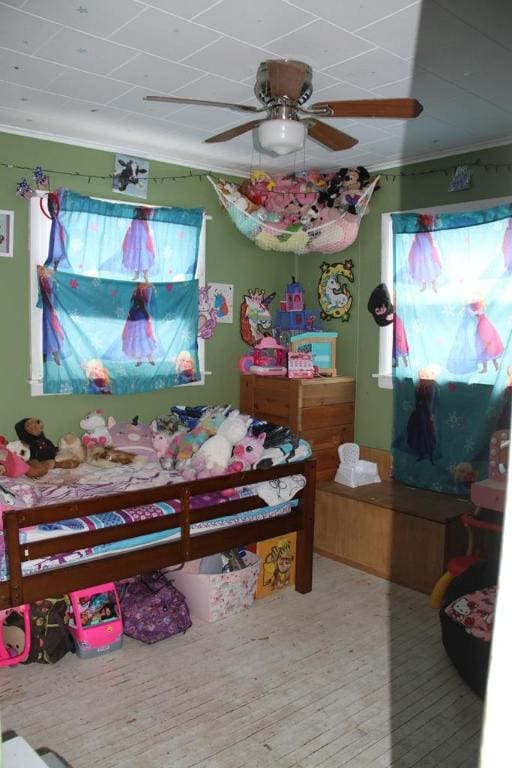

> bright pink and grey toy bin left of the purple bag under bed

[{"left": 68, "top": 582, "right": 123, "bottom": 659}]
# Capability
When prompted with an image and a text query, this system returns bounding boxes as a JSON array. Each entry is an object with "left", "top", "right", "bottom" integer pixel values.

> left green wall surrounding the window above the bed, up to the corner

[{"left": 0, "top": 133, "right": 293, "bottom": 442}]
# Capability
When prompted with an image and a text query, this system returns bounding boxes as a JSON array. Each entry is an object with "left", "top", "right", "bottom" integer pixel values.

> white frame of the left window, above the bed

[{"left": 29, "top": 191, "right": 206, "bottom": 397}]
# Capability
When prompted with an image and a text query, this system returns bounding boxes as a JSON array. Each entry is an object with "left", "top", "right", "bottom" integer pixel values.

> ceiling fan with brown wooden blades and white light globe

[{"left": 144, "top": 59, "right": 423, "bottom": 155}]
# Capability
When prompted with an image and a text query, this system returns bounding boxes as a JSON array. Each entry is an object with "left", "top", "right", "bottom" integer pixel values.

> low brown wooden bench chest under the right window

[{"left": 314, "top": 452, "right": 471, "bottom": 594}]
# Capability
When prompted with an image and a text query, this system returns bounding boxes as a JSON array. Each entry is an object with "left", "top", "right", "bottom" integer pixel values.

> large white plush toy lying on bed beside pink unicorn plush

[{"left": 190, "top": 410, "right": 251, "bottom": 476}]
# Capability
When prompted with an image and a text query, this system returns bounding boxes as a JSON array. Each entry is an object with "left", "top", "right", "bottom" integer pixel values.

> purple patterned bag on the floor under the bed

[{"left": 120, "top": 571, "right": 192, "bottom": 643}]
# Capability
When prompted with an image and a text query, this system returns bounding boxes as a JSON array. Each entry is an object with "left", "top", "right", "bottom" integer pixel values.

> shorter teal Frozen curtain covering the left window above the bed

[{"left": 38, "top": 190, "right": 203, "bottom": 394}]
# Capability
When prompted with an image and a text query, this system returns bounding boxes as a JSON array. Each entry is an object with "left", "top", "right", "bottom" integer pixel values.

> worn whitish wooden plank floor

[{"left": 0, "top": 557, "right": 482, "bottom": 768}]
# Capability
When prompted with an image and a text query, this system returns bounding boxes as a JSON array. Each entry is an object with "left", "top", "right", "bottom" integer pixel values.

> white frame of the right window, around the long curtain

[{"left": 376, "top": 196, "right": 512, "bottom": 389}]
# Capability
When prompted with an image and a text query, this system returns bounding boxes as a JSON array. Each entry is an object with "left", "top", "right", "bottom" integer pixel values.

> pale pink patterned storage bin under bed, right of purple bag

[{"left": 169, "top": 552, "right": 260, "bottom": 621}]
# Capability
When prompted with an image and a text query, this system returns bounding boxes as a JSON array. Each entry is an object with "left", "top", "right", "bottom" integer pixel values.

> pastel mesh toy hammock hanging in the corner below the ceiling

[{"left": 208, "top": 171, "right": 379, "bottom": 254}]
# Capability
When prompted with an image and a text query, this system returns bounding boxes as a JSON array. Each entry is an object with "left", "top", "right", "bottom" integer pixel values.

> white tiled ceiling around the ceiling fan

[{"left": 0, "top": 0, "right": 512, "bottom": 174}]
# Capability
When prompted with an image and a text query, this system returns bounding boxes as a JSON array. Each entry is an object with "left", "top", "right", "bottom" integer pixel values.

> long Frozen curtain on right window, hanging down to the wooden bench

[{"left": 392, "top": 204, "right": 512, "bottom": 493}]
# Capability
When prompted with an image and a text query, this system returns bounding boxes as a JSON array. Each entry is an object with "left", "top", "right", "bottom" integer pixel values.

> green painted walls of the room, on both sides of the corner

[{"left": 0, "top": 133, "right": 512, "bottom": 449}]
